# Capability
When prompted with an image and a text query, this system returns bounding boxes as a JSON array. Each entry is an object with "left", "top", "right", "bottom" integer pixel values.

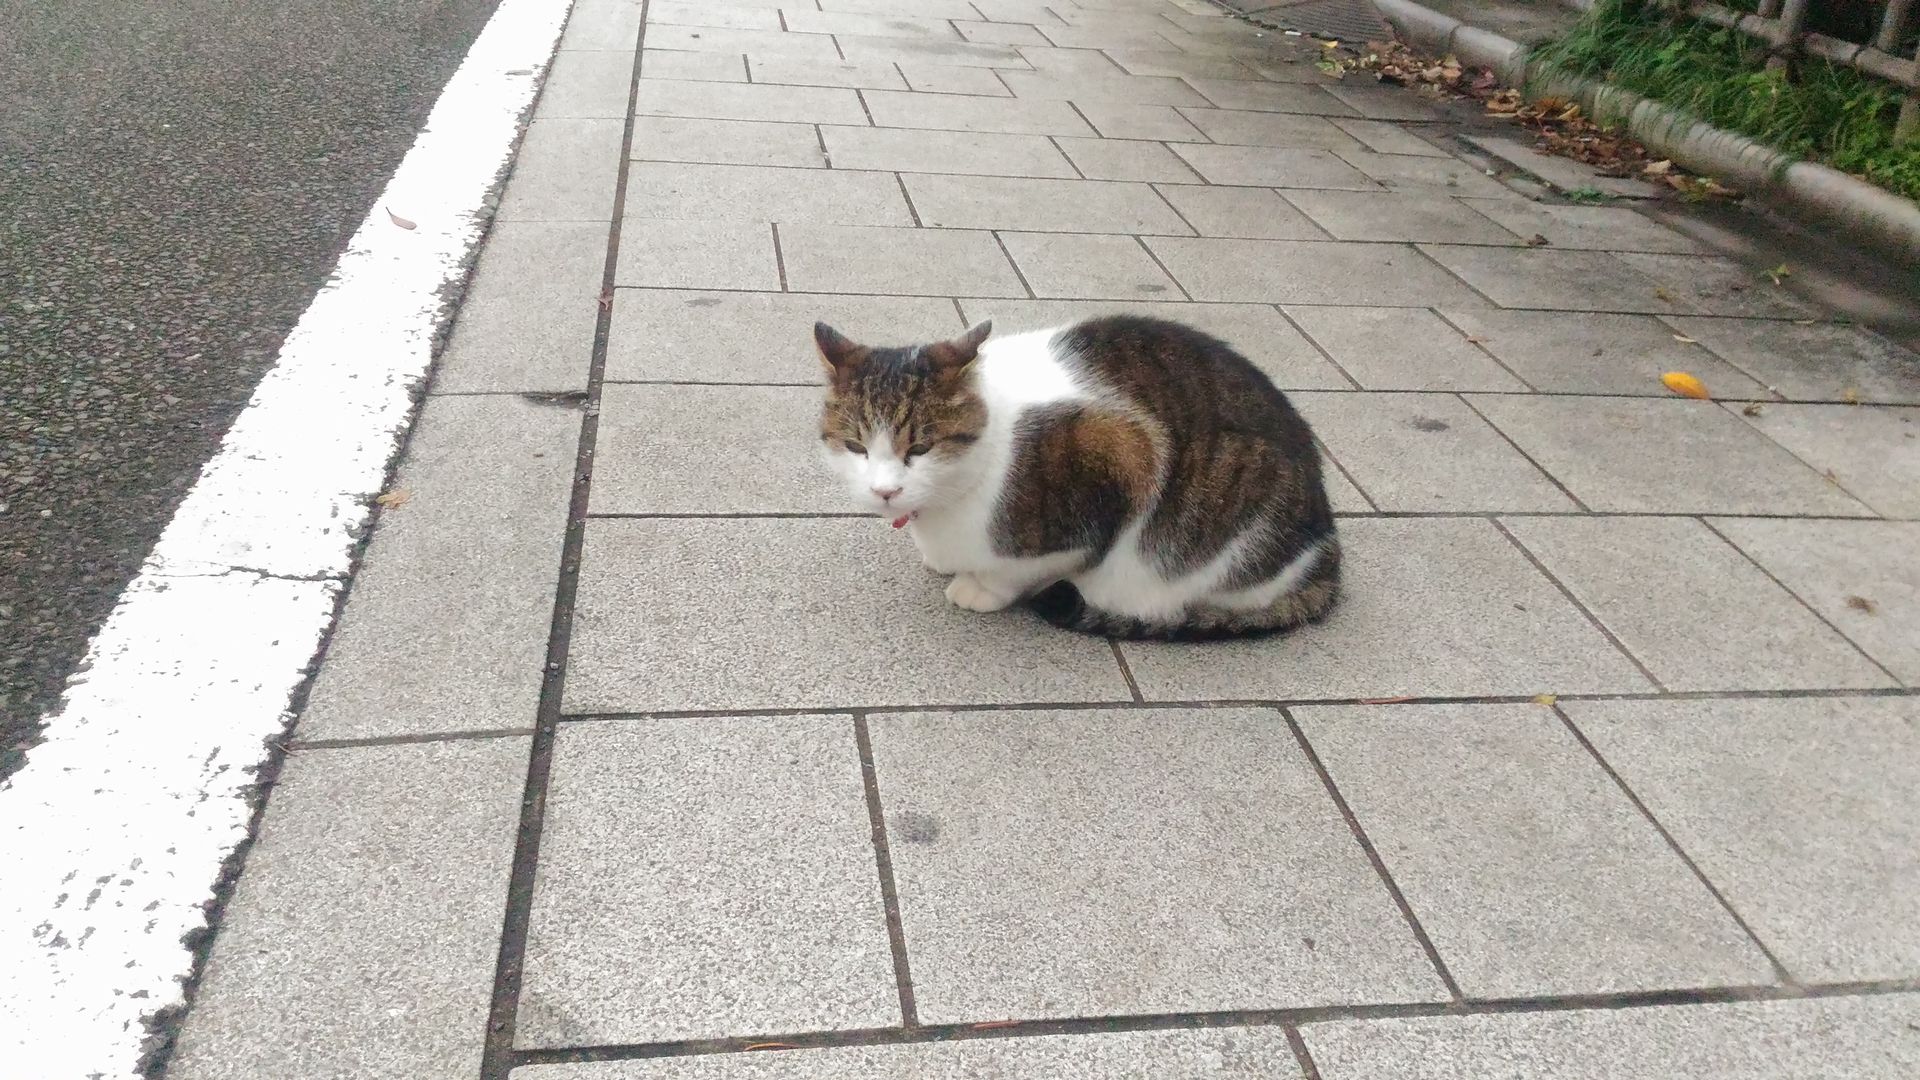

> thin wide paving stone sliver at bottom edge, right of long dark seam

[{"left": 513, "top": 1028, "right": 1300, "bottom": 1080}]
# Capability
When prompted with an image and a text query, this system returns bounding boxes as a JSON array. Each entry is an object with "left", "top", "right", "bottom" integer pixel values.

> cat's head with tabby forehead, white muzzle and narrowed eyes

[{"left": 814, "top": 315, "right": 993, "bottom": 517}]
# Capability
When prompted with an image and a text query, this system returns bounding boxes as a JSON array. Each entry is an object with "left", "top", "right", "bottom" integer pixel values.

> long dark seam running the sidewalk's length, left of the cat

[{"left": 480, "top": 0, "right": 651, "bottom": 1080}]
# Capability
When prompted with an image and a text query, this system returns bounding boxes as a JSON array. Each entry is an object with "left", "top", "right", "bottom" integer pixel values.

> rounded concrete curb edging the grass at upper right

[{"left": 1373, "top": 0, "right": 1920, "bottom": 267}]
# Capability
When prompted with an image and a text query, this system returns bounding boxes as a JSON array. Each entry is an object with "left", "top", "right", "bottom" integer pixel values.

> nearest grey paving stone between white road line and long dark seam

[{"left": 167, "top": 734, "right": 532, "bottom": 1080}]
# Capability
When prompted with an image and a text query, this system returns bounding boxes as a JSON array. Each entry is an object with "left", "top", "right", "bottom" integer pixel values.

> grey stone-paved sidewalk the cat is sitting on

[{"left": 167, "top": 0, "right": 1920, "bottom": 1080}]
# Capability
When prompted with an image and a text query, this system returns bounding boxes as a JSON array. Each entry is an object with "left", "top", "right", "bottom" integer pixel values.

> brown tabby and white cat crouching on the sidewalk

[{"left": 814, "top": 315, "right": 1340, "bottom": 640}]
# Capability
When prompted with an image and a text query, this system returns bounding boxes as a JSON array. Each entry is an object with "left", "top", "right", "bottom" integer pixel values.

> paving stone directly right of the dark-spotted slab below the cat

[{"left": 1296, "top": 703, "right": 1774, "bottom": 997}]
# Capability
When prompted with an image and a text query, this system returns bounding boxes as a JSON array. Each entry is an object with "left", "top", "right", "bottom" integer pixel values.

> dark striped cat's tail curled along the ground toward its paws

[{"left": 1027, "top": 542, "right": 1340, "bottom": 642}]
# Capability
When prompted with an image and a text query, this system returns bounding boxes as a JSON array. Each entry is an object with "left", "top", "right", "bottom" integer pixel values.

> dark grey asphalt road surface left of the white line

[{"left": 0, "top": 0, "right": 497, "bottom": 776}]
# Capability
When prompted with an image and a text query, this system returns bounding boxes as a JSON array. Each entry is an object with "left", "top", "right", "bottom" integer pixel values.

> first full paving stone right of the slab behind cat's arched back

[{"left": 1286, "top": 307, "right": 1526, "bottom": 390}]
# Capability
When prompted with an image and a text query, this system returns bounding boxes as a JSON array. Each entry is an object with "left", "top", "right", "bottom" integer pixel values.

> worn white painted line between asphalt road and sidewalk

[{"left": 0, "top": 0, "right": 568, "bottom": 1080}]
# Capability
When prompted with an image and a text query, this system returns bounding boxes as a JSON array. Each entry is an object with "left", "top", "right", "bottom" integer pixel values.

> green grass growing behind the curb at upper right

[{"left": 1534, "top": 0, "right": 1920, "bottom": 200}]
